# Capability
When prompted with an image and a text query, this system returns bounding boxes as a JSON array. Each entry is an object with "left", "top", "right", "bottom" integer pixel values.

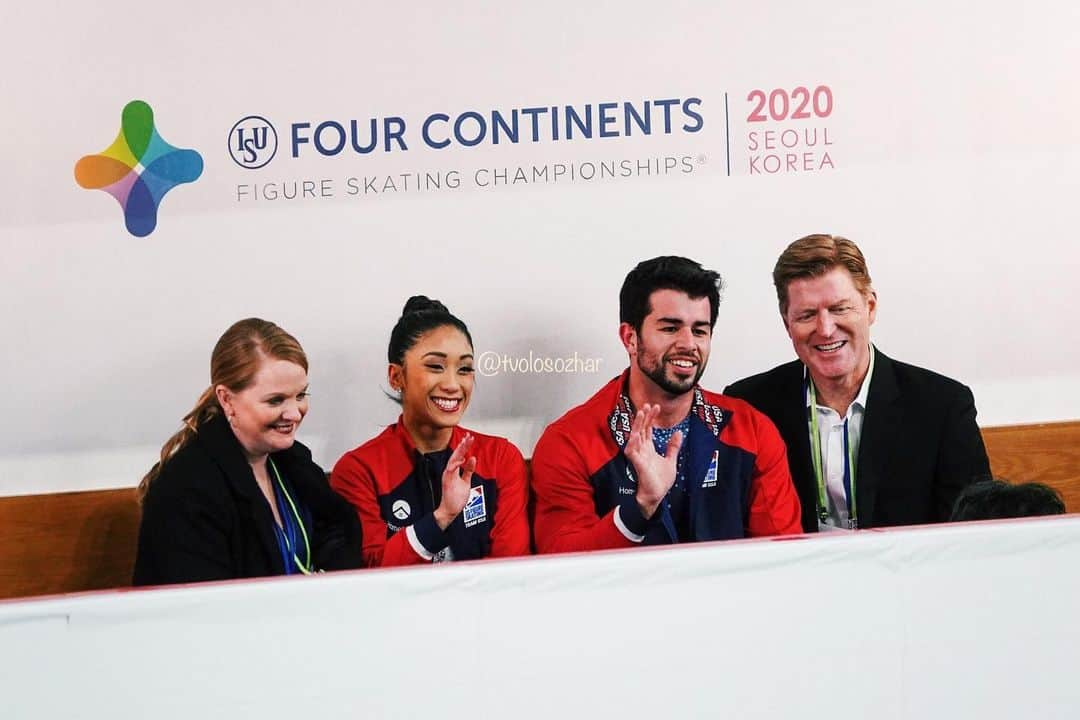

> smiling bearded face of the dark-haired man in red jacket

[{"left": 620, "top": 289, "right": 713, "bottom": 396}]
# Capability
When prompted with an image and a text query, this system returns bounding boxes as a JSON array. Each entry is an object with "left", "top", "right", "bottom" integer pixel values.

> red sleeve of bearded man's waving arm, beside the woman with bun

[{"left": 532, "top": 426, "right": 640, "bottom": 553}]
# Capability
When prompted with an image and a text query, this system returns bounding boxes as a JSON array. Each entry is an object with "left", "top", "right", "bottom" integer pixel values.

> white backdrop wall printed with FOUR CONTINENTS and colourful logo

[{"left": 0, "top": 0, "right": 1080, "bottom": 494}]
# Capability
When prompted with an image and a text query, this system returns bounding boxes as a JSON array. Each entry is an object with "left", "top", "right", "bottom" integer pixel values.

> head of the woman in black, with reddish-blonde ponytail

[{"left": 139, "top": 317, "right": 308, "bottom": 499}]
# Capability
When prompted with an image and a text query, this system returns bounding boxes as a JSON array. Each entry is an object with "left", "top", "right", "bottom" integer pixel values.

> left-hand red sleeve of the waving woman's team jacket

[{"left": 330, "top": 453, "right": 430, "bottom": 568}]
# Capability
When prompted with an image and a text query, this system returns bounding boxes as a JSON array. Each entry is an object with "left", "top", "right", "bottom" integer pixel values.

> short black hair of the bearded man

[{"left": 619, "top": 255, "right": 724, "bottom": 332}]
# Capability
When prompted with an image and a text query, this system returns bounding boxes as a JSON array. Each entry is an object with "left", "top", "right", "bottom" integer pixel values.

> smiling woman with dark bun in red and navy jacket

[{"left": 330, "top": 296, "right": 529, "bottom": 567}]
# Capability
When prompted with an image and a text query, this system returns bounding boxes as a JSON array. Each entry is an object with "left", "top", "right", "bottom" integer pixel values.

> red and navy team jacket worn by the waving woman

[{"left": 330, "top": 418, "right": 529, "bottom": 567}]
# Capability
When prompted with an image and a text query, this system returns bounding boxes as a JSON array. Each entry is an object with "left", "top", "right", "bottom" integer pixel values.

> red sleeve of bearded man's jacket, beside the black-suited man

[{"left": 746, "top": 406, "right": 802, "bottom": 538}]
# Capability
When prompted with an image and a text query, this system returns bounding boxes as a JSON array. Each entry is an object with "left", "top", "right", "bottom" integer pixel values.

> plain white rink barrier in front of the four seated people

[{"left": 0, "top": 516, "right": 1080, "bottom": 720}]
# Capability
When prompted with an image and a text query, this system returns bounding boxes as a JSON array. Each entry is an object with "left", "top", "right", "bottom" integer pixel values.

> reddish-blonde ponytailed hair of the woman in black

[{"left": 137, "top": 317, "right": 308, "bottom": 502}]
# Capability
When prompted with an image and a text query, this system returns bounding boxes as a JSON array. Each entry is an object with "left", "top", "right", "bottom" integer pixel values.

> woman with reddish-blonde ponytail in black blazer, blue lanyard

[{"left": 134, "top": 318, "right": 361, "bottom": 585}]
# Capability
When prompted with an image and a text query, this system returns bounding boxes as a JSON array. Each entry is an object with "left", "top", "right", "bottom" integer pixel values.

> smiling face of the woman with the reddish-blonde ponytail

[{"left": 215, "top": 355, "right": 308, "bottom": 461}]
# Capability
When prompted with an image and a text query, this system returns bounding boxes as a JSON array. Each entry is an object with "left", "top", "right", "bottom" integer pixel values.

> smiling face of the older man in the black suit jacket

[{"left": 783, "top": 268, "right": 877, "bottom": 389}]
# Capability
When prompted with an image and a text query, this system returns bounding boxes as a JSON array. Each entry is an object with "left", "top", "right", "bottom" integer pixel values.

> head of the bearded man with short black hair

[{"left": 619, "top": 256, "right": 723, "bottom": 396}]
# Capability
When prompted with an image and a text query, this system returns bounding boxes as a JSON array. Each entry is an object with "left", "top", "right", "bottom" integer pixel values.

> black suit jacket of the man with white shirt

[{"left": 724, "top": 350, "right": 990, "bottom": 532}]
